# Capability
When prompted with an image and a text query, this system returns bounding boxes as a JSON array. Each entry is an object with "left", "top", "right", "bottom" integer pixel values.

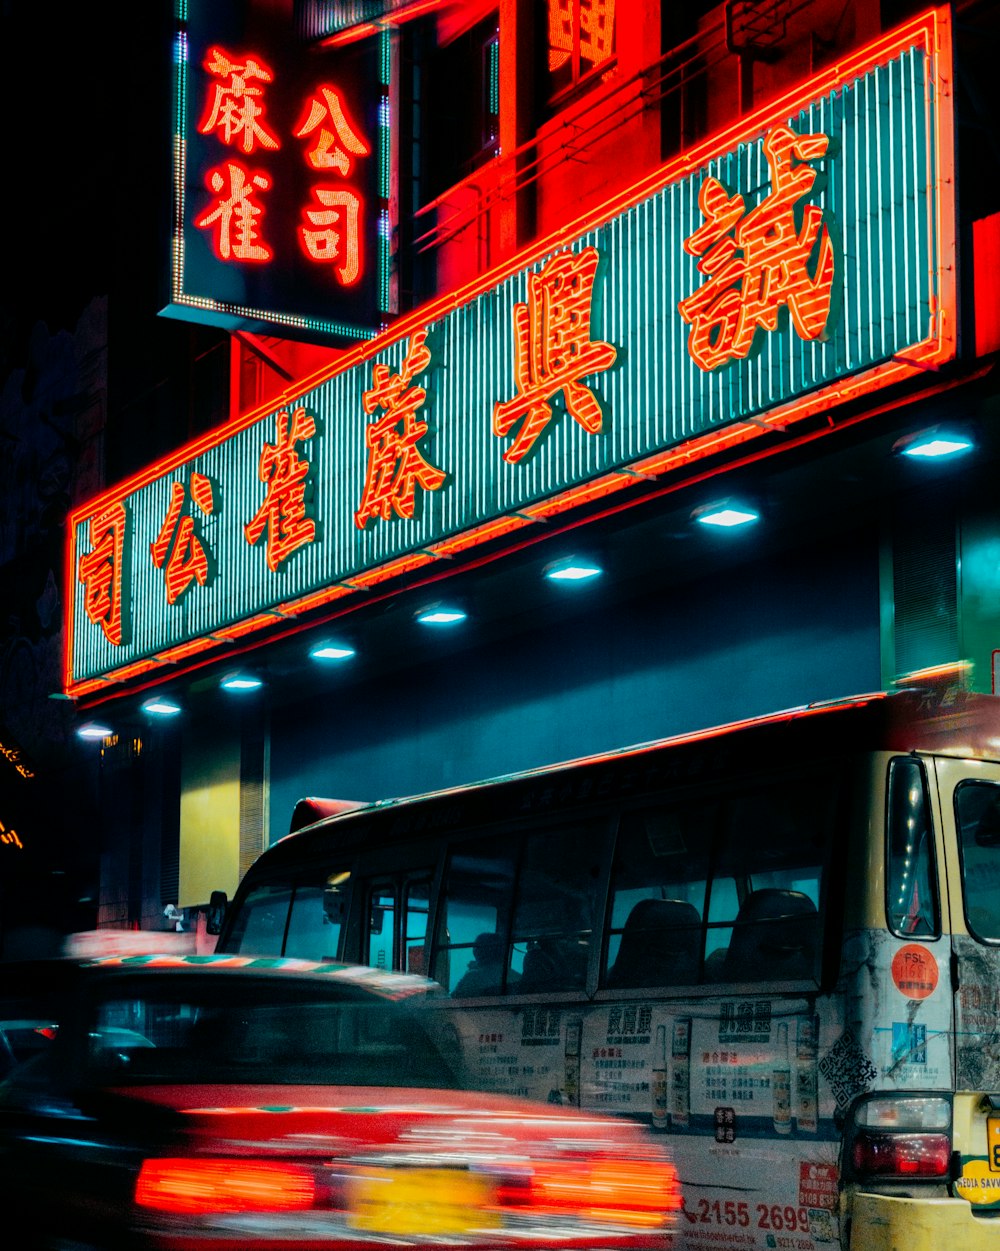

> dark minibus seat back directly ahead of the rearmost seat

[{"left": 607, "top": 899, "right": 701, "bottom": 987}]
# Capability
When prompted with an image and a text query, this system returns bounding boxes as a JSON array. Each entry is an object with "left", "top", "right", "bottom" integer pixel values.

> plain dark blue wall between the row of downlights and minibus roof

[{"left": 270, "top": 533, "right": 880, "bottom": 841}]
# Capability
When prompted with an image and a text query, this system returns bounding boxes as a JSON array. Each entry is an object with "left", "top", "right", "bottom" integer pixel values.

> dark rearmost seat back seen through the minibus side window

[{"left": 726, "top": 887, "right": 820, "bottom": 982}]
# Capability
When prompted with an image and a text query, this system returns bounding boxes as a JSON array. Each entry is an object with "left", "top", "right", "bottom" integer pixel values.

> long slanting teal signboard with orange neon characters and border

[{"left": 65, "top": 9, "right": 956, "bottom": 697}]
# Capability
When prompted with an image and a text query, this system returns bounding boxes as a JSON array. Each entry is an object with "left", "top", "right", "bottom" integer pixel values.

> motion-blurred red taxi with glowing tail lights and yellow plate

[{"left": 0, "top": 955, "right": 680, "bottom": 1251}]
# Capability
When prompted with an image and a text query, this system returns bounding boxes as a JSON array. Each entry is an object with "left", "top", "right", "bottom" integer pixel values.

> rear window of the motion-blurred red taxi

[{"left": 81, "top": 973, "right": 456, "bottom": 1087}]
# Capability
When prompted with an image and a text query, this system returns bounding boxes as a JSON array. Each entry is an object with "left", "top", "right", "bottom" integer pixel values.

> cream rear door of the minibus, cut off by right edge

[{"left": 937, "top": 759, "right": 1000, "bottom": 1217}]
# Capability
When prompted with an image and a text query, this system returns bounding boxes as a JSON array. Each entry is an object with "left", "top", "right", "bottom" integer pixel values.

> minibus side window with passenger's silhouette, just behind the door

[{"left": 431, "top": 838, "right": 519, "bottom": 996}]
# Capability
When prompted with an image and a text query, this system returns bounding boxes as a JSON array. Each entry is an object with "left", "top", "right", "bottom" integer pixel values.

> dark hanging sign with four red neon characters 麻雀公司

[{"left": 163, "top": 0, "right": 397, "bottom": 344}]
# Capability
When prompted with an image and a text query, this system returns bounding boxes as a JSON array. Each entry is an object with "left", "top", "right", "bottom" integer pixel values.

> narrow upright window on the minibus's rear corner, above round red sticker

[{"left": 885, "top": 757, "right": 941, "bottom": 938}]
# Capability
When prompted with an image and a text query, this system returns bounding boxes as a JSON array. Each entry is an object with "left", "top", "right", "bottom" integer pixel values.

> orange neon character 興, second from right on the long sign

[{"left": 493, "top": 248, "right": 617, "bottom": 464}]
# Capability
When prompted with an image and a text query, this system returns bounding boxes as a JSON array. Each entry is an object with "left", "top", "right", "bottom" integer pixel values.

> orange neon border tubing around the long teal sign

[{"left": 63, "top": 6, "right": 957, "bottom": 698}]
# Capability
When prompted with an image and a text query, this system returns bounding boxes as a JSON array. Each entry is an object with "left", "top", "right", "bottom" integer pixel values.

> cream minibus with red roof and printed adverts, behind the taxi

[{"left": 217, "top": 689, "right": 1000, "bottom": 1251}]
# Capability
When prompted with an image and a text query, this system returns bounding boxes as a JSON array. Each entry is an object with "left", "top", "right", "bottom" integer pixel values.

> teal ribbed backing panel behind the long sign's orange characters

[{"left": 66, "top": 14, "right": 954, "bottom": 688}]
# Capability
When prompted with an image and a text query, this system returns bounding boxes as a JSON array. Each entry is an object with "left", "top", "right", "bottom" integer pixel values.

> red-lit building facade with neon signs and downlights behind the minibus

[{"left": 3, "top": 0, "right": 1000, "bottom": 928}]
